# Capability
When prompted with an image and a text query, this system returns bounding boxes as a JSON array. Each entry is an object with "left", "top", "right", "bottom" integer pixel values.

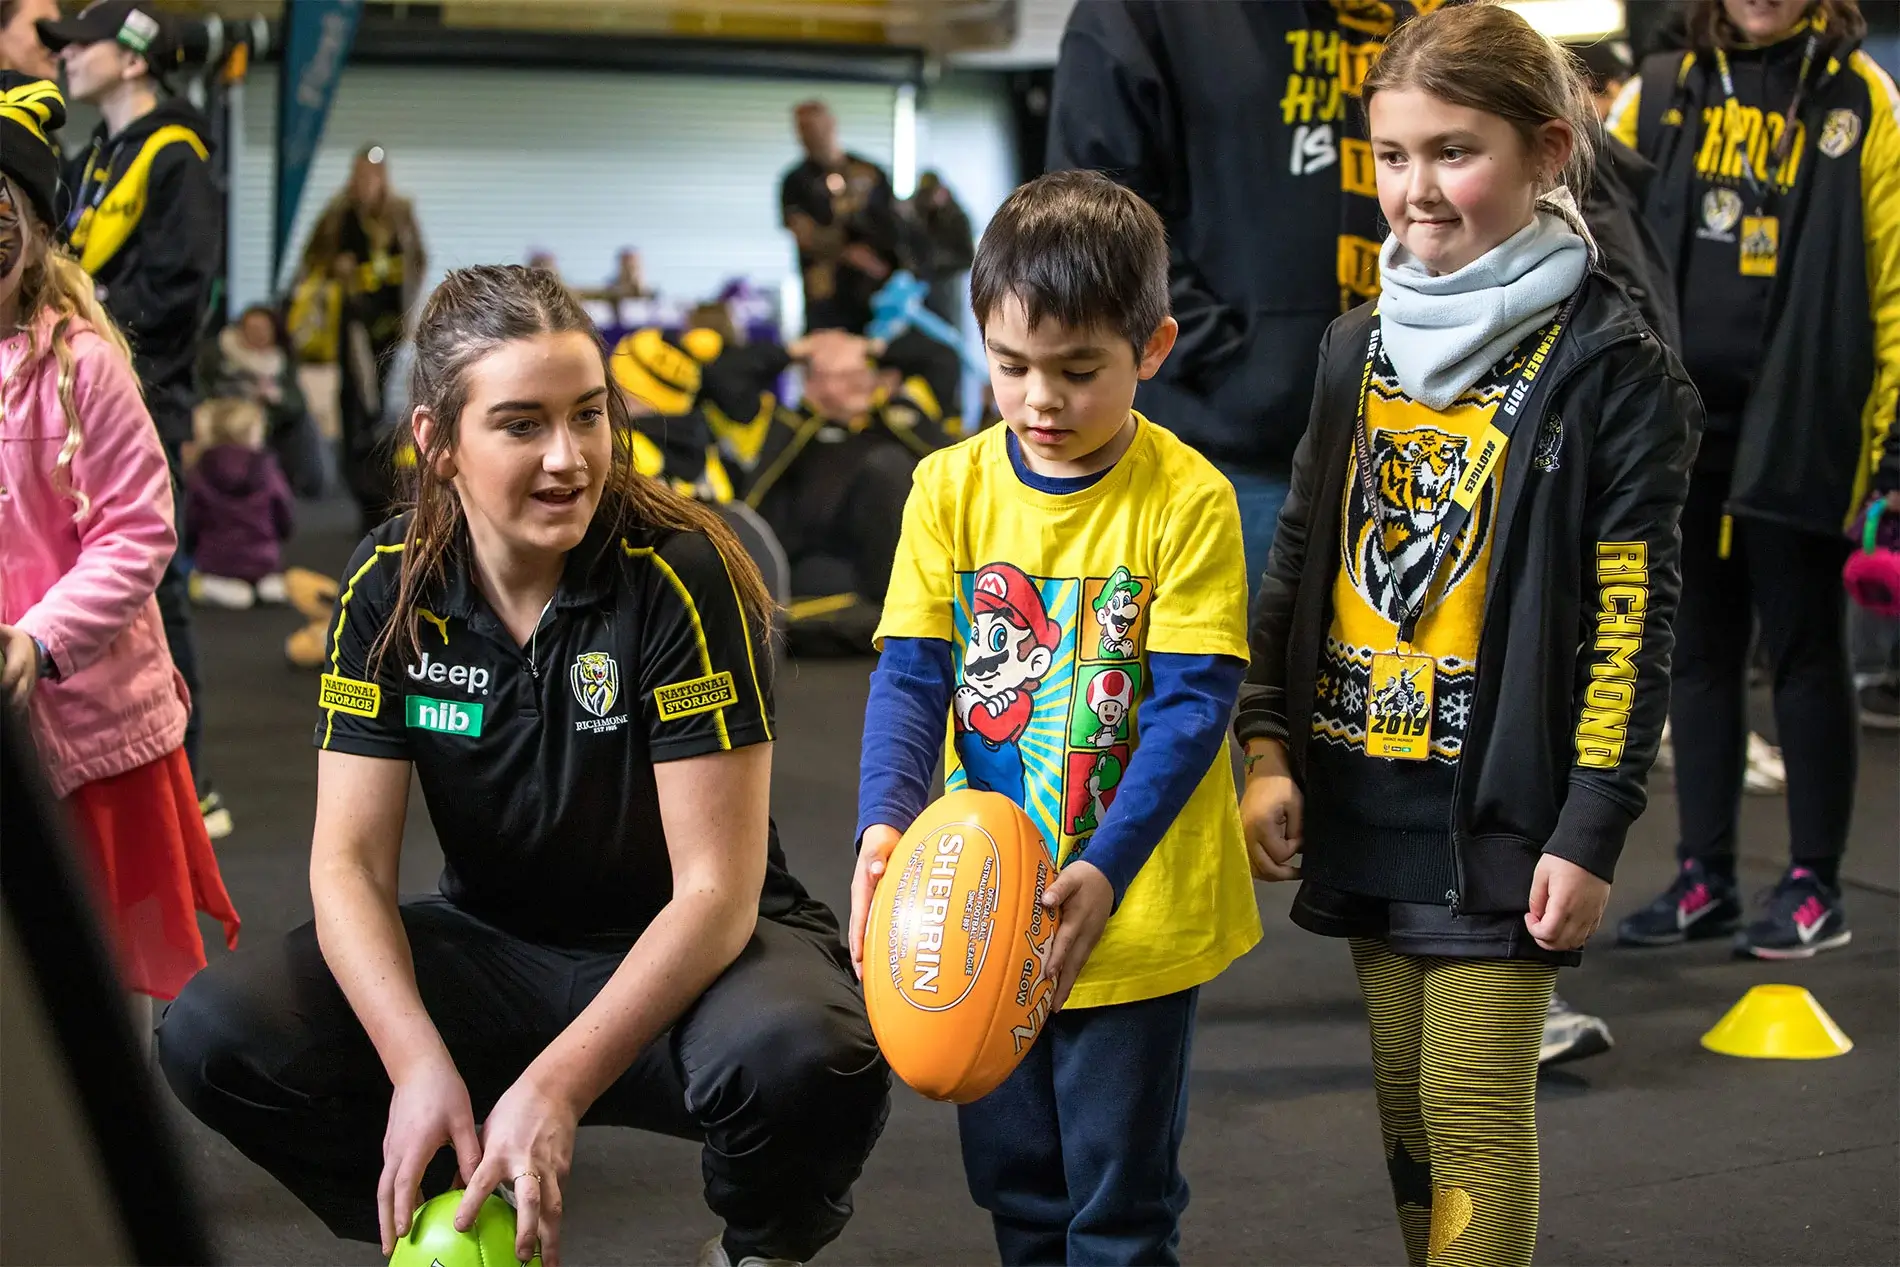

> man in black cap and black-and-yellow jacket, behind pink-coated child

[{"left": 40, "top": 0, "right": 230, "bottom": 838}]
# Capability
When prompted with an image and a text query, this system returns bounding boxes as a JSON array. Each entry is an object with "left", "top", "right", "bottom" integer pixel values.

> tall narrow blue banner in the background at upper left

[{"left": 270, "top": 0, "right": 363, "bottom": 283}]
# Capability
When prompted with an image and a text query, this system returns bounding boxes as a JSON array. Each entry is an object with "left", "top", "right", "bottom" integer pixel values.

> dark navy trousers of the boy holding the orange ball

[{"left": 958, "top": 990, "right": 1201, "bottom": 1267}]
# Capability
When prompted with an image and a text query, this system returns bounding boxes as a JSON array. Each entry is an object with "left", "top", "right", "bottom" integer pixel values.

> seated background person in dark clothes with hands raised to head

[{"left": 739, "top": 331, "right": 948, "bottom": 615}]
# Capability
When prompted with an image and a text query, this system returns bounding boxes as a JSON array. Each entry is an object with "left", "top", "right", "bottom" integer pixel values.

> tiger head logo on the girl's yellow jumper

[{"left": 1345, "top": 427, "right": 1492, "bottom": 625}]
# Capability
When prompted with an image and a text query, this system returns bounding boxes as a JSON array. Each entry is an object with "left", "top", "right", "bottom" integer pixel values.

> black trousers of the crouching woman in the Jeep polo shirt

[{"left": 158, "top": 898, "right": 889, "bottom": 1261}]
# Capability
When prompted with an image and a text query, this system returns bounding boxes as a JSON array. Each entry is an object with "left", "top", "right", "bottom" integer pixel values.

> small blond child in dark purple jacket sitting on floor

[{"left": 184, "top": 397, "right": 295, "bottom": 610}]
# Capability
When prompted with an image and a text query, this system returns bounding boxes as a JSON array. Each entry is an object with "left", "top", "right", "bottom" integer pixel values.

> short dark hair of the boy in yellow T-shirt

[{"left": 969, "top": 171, "right": 1169, "bottom": 361}]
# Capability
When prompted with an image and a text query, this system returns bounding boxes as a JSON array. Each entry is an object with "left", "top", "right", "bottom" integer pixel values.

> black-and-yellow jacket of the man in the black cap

[{"left": 68, "top": 99, "right": 224, "bottom": 444}]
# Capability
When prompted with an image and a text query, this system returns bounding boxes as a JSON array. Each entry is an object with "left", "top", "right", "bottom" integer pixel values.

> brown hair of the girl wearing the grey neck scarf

[{"left": 1360, "top": 0, "right": 1600, "bottom": 199}]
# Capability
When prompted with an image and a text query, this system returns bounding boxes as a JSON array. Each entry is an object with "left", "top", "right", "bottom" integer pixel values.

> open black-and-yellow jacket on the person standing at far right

[{"left": 1607, "top": 34, "right": 1900, "bottom": 536}]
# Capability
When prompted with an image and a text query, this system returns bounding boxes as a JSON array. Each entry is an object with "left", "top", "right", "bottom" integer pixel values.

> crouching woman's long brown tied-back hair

[{"left": 371, "top": 264, "right": 773, "bottom": 665}]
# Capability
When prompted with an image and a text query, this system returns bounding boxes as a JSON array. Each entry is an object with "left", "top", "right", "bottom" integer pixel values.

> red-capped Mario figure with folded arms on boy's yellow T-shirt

[{"left": 952, "top": 562, "right": 1062, "bottom": 805}]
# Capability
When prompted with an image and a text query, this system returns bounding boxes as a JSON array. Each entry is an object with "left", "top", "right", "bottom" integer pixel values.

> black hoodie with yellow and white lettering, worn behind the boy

[{"left": 1047, "top": 0, "right": 1417, "bottom": 471}]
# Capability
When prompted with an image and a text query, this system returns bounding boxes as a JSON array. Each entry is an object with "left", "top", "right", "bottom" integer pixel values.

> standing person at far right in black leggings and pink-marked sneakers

[{"left": 1609, "top": 0, "right": 1900, "bottom": 959}]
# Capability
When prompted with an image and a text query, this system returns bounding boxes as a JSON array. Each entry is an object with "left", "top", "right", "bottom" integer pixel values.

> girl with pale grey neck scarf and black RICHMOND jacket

[{"left": 1237, "top": 6, "right": 1701, "bottom": 1263}]
